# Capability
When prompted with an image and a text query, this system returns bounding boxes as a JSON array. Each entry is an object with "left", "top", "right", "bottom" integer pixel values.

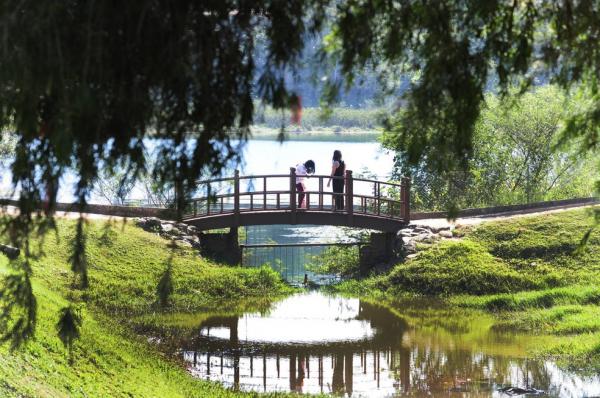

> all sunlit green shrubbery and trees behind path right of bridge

[{"left": 383, "top": 86, "right": 597, "bottom": 210}]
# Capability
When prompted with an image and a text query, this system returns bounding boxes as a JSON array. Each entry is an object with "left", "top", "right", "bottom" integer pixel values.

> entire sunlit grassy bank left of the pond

[{"left": 0, "top": 220, "right": 300, "bottom": 397}]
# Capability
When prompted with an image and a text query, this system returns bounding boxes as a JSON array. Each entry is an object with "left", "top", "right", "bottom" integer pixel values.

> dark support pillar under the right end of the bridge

[{"left": 359, "top": 232, "right": 402, "bottom": 276}]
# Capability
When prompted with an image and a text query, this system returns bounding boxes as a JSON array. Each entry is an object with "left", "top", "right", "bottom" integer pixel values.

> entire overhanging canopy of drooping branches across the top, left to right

[{"left": 0, "top": 0, "right": 600, "bottom": 348}]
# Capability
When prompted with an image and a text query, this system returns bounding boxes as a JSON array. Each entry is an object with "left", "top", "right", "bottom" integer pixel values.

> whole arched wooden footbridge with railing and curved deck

[{"left": 184, "top": 168, "right": 410, "bottom": 232}]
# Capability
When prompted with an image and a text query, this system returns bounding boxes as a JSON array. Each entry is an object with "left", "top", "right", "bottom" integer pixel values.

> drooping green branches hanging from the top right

[{"left": 327, "top": 0, "right": 600, "bottom": 171}]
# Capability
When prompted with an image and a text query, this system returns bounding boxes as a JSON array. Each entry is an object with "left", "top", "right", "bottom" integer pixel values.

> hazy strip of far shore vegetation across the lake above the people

[{"left": 254, "top": 107, "right": 387, "bottom": 130}]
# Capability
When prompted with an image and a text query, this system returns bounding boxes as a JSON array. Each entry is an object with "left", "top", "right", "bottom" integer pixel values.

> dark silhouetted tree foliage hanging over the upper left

[{"left": 0, "top": 0, "right": 324, "bottom": 348}]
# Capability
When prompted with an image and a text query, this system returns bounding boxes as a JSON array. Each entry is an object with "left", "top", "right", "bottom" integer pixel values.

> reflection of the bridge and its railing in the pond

[{"left": 184, "top": 302, "right": 410, "bottom": 396}]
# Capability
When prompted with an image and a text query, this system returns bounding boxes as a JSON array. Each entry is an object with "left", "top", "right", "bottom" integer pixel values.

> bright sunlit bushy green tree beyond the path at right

[{"left": 475, "top": 86, "right": 591, "bottom": 203}]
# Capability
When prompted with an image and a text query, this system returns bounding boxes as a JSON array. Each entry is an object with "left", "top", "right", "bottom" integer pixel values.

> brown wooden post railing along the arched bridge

[{"left": 184, "top": 168, "right": 410, "bottom": 222}]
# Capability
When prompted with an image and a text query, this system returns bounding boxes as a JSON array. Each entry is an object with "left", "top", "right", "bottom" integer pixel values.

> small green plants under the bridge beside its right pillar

[{"left": 306, "top": 246, "right": 359, "bottom": 278}]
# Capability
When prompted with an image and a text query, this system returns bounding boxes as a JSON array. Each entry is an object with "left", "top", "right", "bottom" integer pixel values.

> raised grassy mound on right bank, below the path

[{"left": 338, "top": 210, "right": 600, "bottom": 298}]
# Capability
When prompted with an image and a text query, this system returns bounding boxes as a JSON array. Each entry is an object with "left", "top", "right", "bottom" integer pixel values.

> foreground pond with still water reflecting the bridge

[{"left": 181, "top": 291, "right": 600, "bottom": 397}]
